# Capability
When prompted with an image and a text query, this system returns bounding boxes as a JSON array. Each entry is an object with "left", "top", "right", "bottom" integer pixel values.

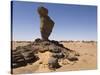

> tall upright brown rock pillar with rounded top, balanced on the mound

[{"left": 38, "top": 7, "right": 54, "bottom": 40}]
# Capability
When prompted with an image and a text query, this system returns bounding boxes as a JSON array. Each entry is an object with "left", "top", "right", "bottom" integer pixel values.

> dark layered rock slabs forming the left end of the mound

[{"left": 11, "top": 46, "right": 39, "bottom": 68}]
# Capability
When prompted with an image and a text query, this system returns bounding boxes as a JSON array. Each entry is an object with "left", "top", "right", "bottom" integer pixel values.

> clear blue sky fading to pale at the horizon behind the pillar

[{"left": 12, "top": 1, "right": 97, "bottom": 40}]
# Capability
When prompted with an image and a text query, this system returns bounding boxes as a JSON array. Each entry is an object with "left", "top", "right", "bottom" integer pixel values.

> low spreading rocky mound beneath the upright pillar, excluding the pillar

[{"left": 11, "top": 38, "right": 79, "bottom": 69}]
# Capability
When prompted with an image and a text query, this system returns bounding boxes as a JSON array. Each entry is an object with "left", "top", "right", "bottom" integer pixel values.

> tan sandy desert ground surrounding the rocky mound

[{"left": 12, "top": 41, "right": 97, "bottom": 74}]
